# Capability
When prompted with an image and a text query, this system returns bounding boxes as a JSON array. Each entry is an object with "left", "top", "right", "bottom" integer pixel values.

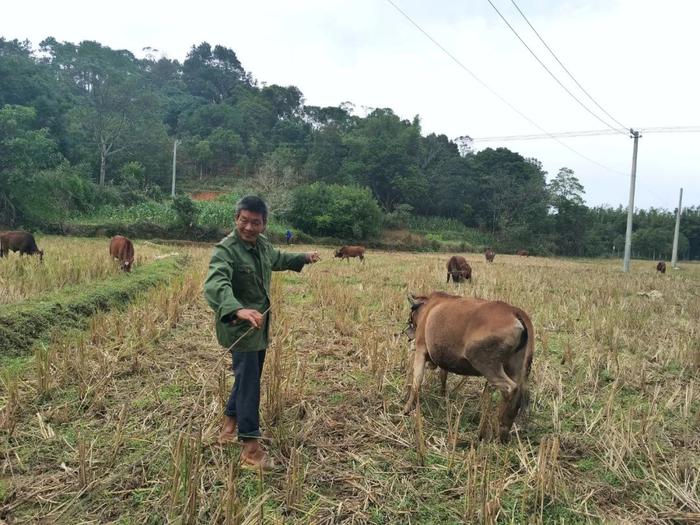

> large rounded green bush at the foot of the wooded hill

[{"left": 289, "top": 182, "right": 382, "bottom": 239}]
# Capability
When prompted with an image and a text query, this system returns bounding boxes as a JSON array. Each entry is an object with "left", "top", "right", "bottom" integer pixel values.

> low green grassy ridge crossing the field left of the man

[{"left": 0, "top": 257, "right": 183, "bottom": 357}]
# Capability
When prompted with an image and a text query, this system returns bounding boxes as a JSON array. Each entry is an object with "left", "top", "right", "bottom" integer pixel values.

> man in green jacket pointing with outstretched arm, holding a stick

[{"left": 204, "top": 196, "right": 319, "bottom": 469}]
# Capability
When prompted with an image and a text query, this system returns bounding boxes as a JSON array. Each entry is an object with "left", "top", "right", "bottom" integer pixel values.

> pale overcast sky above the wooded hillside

[{"left": 0, "top": 0, "right": 700, "bottom": 210}]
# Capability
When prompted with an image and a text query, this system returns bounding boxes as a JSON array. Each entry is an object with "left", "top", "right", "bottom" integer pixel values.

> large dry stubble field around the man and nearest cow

[{"left": 0, "top": 247, "right": 700, "bottom": 524}]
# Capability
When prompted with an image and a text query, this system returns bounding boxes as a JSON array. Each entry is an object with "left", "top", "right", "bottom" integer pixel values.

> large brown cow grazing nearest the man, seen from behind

[{"left": 404, "top": 292, "right": 535, "bottom": 442}]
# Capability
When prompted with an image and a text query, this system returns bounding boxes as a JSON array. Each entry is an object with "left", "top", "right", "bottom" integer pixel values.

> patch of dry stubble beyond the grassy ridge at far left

[{"left": 0, "top": 237, "right": 171, "bottom": 304}]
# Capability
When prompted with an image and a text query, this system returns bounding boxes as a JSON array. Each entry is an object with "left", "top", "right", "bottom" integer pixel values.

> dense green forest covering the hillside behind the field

[{"left": 0, "top": 38, "right": 700, "bottom": 258}]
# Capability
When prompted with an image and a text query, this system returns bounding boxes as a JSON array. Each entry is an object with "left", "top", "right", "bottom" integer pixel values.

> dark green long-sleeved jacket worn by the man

[{"left": 204, "top": 230, "right": 306, "bottom": 352}]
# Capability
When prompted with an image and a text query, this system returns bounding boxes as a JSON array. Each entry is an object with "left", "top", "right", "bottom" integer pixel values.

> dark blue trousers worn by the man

[{"left": 224, "top": 350, "right": 265, "bottom": 439}]
